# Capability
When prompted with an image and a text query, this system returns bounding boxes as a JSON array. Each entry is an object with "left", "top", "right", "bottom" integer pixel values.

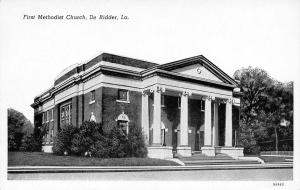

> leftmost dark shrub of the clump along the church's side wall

[{"left": 52, "top": 125, "right": 78, "bottom": 155}]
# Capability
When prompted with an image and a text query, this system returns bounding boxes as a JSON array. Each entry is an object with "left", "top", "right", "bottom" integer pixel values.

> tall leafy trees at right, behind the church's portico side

[{"left": 234, "top": 67, "right": 293, "bottom": 153}]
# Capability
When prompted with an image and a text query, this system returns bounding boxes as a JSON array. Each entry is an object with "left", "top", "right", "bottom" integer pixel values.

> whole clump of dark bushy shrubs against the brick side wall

[{"left": 53, "top": 121, "right": 147, "bottom": 158}]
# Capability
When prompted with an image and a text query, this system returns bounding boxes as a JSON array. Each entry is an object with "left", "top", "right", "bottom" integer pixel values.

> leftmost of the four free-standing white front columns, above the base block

[{"left": 152, "top": 87, "right": 162, "bottom": 146}]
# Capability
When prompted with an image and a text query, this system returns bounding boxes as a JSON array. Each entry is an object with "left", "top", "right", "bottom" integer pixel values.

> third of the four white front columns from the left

[{"left": 204, "top": 96, "right": 212, "bottom": 146}]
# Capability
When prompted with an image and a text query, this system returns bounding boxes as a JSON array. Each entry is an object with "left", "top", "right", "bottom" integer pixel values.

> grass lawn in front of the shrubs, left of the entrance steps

[{"left": 8, "top": 152, "right": 179, "bottom": 166}]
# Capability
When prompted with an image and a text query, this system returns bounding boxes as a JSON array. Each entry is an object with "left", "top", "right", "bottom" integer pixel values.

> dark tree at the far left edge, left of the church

[{"left": 7, "top": 108, "right": 33, "bottom": 151}]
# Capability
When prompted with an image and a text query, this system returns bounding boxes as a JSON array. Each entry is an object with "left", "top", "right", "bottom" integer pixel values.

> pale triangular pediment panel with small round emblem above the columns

[{"left": 172, "top": 63, "right": 222, "bottom": 82}]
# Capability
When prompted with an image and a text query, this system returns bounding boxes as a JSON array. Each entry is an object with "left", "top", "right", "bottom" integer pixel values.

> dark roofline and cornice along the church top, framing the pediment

[{"left": 31, "top": 53, "right": 240, "bottom": 107}]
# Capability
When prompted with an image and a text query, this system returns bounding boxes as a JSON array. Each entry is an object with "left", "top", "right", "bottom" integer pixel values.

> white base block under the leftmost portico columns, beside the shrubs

[{"left": 147, "top": 146, "right": 173, "bottom": 159}]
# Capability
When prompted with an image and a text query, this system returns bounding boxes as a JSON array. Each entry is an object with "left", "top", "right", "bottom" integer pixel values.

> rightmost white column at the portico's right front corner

[{"left": 225, "top": 98, "right": 232, "bottom": 147}]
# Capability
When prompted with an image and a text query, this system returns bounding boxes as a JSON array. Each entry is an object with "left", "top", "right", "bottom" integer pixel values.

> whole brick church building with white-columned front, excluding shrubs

[{"left": 31, "top": 53, "right": 243, "bottom": 158}]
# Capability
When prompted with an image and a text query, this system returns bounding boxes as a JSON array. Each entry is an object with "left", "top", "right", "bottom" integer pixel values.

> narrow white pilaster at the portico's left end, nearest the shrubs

[{"left": 142, "top": 91, "right": 149, "bottom": 145}]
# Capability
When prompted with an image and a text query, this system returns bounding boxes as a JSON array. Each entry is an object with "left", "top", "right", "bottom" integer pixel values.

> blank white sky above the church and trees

[{"left": 0, "top": 0, "right": 300, "bottom": 122}]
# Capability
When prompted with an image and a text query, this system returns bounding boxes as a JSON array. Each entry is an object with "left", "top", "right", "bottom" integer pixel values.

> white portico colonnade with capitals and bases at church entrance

[{"left": 142, "top": 85, "right": 242, "bottom": 158}]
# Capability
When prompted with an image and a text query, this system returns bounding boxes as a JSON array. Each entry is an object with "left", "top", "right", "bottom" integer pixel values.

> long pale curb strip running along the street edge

[{"left": 8, "top": 163, "right": 293, "bottom": 174}]
